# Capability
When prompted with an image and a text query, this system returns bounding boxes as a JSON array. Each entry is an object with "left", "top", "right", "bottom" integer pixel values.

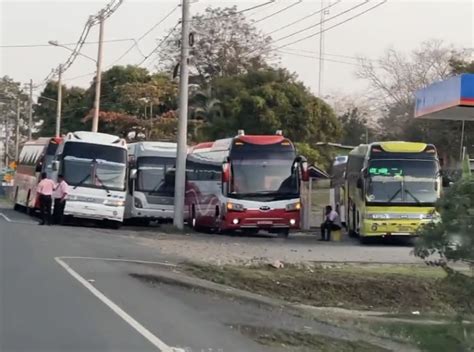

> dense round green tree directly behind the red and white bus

[{"left": 203, "top": 69, "right": 340, "bottom": 143}]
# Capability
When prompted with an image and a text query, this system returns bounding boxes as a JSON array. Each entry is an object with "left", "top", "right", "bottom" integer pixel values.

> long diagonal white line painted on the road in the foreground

[{"left": 54, "top": 257, "right": 184, "bottom": 352}]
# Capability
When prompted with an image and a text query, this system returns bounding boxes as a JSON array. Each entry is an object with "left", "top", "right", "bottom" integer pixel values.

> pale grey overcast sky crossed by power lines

[{"left": 0, "top": 0, "right": 474, "bottom": 102}]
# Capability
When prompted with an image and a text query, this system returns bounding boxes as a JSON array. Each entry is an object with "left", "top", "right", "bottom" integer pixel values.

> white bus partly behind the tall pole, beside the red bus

[{"left": 125, "top": 142, "right": 177, "bottom": 224}]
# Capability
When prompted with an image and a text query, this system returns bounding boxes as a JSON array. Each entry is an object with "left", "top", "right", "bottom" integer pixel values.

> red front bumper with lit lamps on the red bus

[{"left": 221, "top": 209, "right": 300, "bottom": 231}]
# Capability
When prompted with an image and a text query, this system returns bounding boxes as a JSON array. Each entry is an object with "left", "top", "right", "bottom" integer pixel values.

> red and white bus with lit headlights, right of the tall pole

[{"left": 185, "top": 131, "right": 308, "bottom": 237}]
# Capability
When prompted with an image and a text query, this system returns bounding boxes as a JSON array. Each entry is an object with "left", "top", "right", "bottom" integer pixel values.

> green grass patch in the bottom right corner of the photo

[{"left": 372, "top": 323, "right": 474, "bottom": 352}]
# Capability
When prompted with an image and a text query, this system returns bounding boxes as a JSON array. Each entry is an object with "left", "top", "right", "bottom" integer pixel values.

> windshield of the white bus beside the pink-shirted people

[{"left": 62, "top": 142, "right": 127, "bottom": 191}]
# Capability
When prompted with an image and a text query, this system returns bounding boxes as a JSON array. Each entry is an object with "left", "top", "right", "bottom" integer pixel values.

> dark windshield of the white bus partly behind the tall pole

[{"left": 135, "top": 157, "right": 176, "bottom": 197}]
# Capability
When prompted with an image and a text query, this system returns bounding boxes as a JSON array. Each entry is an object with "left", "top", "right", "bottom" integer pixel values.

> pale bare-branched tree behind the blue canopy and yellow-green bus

[{"left": 358, "top": 40, "right": 467, "bottom": 164}]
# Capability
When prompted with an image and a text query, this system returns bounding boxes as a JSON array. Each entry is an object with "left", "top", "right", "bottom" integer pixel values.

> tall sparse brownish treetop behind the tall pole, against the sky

[{"left": 158, "top": 6, "right": 275, "bottom": 84}]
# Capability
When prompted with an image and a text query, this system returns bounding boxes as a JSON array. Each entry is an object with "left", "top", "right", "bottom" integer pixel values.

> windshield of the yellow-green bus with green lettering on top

[{"left": 366, "top": 160, "right": 439, "bottom": 204}]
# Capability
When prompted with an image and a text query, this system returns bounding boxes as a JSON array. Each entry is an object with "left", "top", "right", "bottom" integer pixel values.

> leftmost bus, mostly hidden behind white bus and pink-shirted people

[{"left": 11, "top": 137, "right": 62, "bottom": 212}]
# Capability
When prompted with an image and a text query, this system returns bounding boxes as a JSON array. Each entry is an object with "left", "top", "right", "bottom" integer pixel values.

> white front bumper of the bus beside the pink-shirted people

[{"left": 64, "top": 201, "right": 125, "bottom": 222}]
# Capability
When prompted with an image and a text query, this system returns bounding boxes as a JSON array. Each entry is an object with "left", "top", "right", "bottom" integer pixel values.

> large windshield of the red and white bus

[{"left": 231, "top": 151, "right": 299, "bottom": 199}]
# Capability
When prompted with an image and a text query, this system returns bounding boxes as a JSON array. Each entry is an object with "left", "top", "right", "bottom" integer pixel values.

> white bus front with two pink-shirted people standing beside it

[{"left": 53, "top": 132, "right": 127, "bottom": 228}]
